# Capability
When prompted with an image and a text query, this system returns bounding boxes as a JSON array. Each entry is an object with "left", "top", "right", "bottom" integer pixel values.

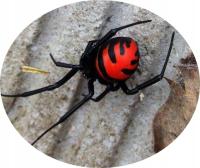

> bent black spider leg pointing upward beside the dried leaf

[{"left": 121, "top": 32, "right": 175, "bottom": 95}]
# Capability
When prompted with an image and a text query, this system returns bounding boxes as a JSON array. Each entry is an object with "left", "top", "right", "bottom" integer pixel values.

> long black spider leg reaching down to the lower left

[{"left": 32, "top": 79, "right": 94, "bottom": 145}]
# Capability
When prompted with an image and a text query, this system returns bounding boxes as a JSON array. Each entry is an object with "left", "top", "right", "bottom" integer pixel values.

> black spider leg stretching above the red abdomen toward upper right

[{"left": 94, "top": 20, "right": 151, "bottom": 48}]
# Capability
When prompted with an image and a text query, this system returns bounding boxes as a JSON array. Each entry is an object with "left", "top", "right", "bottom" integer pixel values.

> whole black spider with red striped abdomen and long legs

[{"left": 1, "top": 20, "right": 175, "bottom": 145}]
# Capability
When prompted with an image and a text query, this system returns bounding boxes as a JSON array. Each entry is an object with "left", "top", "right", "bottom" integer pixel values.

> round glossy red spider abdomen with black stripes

[{"left": 96, "top": 37, "right": 139, "bottom": 81}]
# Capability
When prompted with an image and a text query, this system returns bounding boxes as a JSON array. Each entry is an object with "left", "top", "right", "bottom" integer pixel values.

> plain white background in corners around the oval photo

[{"left": 0, "top": 0, "right": 200, "bottom": 168}]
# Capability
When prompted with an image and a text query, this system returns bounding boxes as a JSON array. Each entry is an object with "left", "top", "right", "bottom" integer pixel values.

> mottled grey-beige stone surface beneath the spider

[{"left": 1, "top": 1, "right": 197, "bottom": 167}]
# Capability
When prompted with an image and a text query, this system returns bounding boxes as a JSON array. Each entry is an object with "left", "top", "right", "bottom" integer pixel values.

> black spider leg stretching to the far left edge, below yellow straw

[{"left": 1, "top": 68, "right": 78, "bottom": 97}]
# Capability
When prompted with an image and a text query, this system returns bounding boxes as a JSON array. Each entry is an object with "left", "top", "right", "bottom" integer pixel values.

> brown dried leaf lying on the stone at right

[{"left": 153, "top": 55, "right": 200, "bottom": 152}]
